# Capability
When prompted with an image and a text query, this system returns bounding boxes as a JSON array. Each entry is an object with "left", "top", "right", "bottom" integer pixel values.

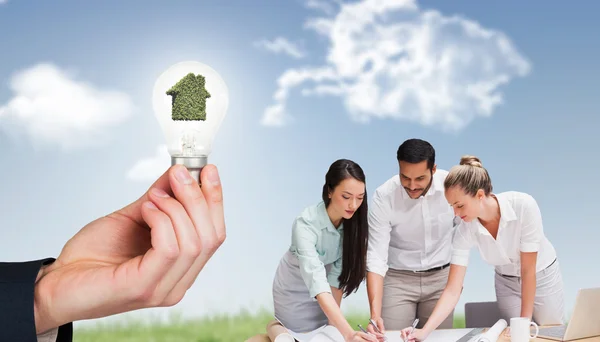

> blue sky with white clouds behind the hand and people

[{"left": 0, "top": 0, "right": 600, "bottom": 326}]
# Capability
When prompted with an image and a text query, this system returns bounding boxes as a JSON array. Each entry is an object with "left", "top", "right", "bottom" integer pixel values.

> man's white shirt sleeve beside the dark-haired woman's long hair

[{"left": 367, "top": 191, "right": 392, "bottom": 277}]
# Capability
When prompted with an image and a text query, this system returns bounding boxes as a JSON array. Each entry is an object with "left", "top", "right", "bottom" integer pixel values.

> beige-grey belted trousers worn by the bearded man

[{"left": 381, "top": 267, "right": 454, "bottom": 330}]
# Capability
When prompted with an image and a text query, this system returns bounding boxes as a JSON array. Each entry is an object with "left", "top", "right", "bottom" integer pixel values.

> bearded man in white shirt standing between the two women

[{"left": 367, "top": 139, "right": 454, "bottom": 331}]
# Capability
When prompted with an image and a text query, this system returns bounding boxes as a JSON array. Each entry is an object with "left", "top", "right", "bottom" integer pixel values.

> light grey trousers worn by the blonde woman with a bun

[{"left": 495, "top": 260, "right": 565, "bottom": 325}]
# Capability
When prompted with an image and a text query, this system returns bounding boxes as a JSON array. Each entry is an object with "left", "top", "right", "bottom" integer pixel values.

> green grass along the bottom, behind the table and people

[{"left": 74, "top": 311, "right": 464, "bottom": 342}]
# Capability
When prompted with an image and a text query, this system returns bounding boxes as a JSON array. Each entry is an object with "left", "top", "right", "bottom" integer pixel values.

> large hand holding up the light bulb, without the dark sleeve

[{"left": 34, "top": 165, "right": 226, "bottom": 334}]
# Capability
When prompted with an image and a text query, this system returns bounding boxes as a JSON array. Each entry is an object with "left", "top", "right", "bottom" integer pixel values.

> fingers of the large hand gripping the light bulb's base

[{"left": 119, "top": 165, "right": 225, "bottom": 307}]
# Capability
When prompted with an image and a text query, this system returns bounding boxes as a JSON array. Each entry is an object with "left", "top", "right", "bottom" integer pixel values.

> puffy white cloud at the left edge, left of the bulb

[{"left": 0, "top": 63, "right": 134, "bottom": 151}]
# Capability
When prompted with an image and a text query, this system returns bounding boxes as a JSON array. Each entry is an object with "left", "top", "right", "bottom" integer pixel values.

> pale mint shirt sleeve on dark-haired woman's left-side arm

[{"left": 291, "top": 216, "right": 331, "bottom": 298}]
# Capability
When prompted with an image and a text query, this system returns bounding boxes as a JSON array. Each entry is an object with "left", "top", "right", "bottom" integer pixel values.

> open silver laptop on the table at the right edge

[{"left": 538, "top": 287, "right": 600, "bottom": 341}]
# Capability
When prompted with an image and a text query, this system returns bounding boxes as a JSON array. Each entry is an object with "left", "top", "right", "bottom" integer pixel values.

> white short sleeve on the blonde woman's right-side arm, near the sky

[{"left": 520, "top": 195, "right": 543, "bottom": 253}]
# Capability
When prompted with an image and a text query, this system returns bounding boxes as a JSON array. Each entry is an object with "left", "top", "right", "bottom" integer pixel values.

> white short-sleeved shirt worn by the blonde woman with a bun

[{"left": 452, "top": 191, "right": 556, "bottom": 276}]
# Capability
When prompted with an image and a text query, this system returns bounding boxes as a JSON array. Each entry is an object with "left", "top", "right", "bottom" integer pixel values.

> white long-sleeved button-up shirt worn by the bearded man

[{"left": 367, "top": 169, "right": 454, "bottom": 276}]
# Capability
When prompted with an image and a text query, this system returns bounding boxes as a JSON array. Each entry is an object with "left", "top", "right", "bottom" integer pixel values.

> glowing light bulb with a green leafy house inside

[{"left": 152, "top": 61, "right": 229, "bottom": 182}]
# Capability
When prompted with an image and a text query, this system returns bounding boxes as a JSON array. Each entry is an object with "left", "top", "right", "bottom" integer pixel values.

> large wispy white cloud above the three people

[{"left": 261, "top": 0, "right": 531, "bottom": 130}]
